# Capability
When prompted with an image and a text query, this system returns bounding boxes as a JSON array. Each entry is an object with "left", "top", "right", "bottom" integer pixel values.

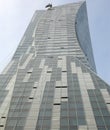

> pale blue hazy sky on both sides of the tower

[{"left": 0, "top": 0, "right": 110, "bottom": 84}]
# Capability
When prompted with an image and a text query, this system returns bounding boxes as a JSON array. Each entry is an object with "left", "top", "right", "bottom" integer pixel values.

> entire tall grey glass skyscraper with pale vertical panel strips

[{"left": 0, "top": 2, "right": 110, "bottom": 130}]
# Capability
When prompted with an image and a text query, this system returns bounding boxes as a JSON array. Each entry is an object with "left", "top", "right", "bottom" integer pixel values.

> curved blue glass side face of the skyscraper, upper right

[{"left": 75, "top": 1, "right": 96, "bottom": 72}]
